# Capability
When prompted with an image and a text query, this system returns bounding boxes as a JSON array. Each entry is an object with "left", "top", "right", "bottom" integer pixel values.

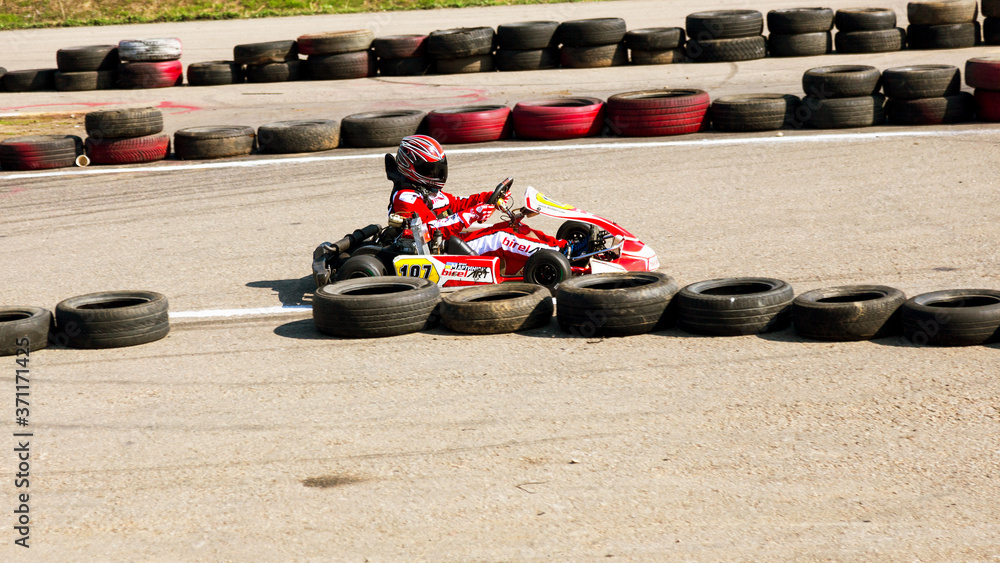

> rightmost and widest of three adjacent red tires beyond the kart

[{"left": 607, "top": 89, "right": 711, "bottom": 137}]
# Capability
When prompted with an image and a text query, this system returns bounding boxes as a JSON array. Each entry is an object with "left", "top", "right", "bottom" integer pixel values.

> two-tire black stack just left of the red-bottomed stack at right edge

[{"left": 882, "top": 65, "right": 976, "bottom": 125}]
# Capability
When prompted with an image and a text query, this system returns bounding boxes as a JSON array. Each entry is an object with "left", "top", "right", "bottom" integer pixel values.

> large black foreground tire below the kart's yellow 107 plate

[{"left": 313, "top": 276, "right": 441, "bottom": 338}]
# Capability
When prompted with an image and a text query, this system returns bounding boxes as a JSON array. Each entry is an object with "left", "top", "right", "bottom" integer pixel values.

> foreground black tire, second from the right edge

[{"left": 792, "top": 285, "right": 906, "bottom": 342}]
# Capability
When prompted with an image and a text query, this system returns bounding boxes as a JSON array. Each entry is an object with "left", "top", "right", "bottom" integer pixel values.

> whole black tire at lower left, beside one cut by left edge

[{"left": 56, "top": 291, "right": 170, "bottom": 348}]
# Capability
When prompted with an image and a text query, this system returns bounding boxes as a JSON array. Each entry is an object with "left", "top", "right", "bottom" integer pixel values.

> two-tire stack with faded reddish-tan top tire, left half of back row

[{"left": 297, "top": 29, "right": 376, "bottom": 80}]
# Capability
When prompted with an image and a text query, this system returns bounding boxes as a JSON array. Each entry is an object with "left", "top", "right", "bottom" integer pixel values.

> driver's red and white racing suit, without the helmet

[{"left": 390, "top": 188, "right": 566, "bottom": 275}]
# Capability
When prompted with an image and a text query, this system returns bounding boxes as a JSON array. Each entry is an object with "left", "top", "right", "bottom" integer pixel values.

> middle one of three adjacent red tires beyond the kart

[{"left": 511, "top": 98, "right": 604, "bottom": 140}]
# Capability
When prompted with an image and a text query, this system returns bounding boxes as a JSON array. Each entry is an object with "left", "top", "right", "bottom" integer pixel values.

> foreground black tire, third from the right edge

[{"left": 676, "top": 278, "right": 794, "bottom": 336}]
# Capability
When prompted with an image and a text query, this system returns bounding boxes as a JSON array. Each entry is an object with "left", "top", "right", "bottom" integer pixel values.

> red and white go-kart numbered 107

[{"left": 312, "top": 178, "right": 660, "bottom": 289}]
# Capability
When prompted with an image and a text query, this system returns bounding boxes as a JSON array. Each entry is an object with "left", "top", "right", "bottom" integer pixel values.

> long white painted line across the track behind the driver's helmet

[{"left": 0, "top": 129, "right": 1000, "bottom": 180}]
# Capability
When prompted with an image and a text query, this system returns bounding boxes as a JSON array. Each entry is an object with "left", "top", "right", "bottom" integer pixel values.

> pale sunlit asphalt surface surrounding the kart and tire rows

[{"left": 0, "top": 2, "right": 1000, "bottom": 561}]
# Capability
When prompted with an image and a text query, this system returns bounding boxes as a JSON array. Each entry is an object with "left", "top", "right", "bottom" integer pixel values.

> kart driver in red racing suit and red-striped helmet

[{"left": 387, "top": 135, "right": 587, "bottom": 272}]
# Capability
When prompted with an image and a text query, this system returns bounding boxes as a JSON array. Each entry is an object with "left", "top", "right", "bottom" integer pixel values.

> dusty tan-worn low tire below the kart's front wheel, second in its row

[{"left": 440, "top": 283, "right": 554, "bottom": 334}]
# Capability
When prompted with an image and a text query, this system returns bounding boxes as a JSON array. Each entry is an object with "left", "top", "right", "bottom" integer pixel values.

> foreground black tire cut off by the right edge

[{"left": 900, "top": 289, "right": 1000, "bottom": 346}]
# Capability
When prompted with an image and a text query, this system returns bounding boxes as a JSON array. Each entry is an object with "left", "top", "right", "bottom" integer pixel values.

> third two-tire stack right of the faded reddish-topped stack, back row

[{"left": 494, "top": 21, "right": 559, "bottom": 71}]
